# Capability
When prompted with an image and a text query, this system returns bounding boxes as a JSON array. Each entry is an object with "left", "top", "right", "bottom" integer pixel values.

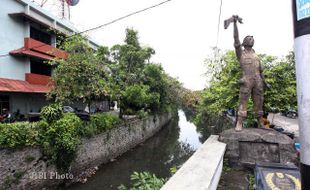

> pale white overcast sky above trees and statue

[{"left": 40, "top": 0, "right": 293, "bottom": 90}]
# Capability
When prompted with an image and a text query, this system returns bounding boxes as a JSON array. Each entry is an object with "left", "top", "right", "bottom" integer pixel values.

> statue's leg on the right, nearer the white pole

[{"left": 252, "top": 80, "right": 264, "bottom": 127}]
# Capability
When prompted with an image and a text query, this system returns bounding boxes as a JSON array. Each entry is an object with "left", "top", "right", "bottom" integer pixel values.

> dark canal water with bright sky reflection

[{"left": 61, "top": 110, "right": 229, "bottom": 190}]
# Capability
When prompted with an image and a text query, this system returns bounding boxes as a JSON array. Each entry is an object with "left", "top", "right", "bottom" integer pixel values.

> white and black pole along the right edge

[{"left": 292, "top": 0, "right": 310, "bottom": 190}]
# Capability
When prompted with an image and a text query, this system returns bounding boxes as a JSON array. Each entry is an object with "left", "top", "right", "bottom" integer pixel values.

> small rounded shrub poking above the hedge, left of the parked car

[{"left": 41, "top": 103, "right": 63, "bottom": 123}]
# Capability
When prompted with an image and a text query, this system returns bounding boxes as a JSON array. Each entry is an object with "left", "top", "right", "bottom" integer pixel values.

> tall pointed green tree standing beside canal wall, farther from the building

[{"left": 98, "top": 29, "right": 182, "bottom": 115}]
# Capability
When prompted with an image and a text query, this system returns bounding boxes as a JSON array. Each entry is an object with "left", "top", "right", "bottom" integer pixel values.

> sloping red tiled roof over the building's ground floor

[{"left": 0, "top": 78, "right": 50, "bottom": 93}]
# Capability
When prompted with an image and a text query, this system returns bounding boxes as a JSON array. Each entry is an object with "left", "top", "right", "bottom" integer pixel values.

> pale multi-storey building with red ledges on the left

[{"left": 0, "top": 0, "right": 97, "bottom": 114}]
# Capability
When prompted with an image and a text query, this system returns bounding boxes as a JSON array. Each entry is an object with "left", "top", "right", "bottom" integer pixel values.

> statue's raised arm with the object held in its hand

[{"left": 224, "top": 15, "right": 242, "bottom": 60}]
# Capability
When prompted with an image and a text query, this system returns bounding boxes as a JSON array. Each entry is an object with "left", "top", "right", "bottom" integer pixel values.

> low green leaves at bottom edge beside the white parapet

[{"left": 117, "top": 172, "right": 167, "bottom": 190}]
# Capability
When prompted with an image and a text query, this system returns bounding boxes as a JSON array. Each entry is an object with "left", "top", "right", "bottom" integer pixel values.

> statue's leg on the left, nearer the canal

[{"left": 235, "top": 83, "right": 251, "bottom": 131}]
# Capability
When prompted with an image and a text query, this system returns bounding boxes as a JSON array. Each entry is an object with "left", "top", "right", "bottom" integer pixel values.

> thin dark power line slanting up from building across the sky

[{"left": 0, "top": 0, "right": 172, "bottom": 58}]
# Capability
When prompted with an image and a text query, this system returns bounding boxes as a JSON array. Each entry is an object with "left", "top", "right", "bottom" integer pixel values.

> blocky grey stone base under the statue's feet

[{"left": 219, "top": 128, "right": 297, "bottom": 168}]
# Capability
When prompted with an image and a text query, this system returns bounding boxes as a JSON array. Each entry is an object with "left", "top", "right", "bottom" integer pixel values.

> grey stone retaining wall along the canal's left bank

[{"left": 0, "top": 114, "right": 172, "bottom": 190}]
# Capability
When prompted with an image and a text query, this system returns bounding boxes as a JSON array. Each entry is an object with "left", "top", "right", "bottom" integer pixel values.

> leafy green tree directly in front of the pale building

[{"left": 48, "top": 36, "right": 109, "bottom": 103}]
